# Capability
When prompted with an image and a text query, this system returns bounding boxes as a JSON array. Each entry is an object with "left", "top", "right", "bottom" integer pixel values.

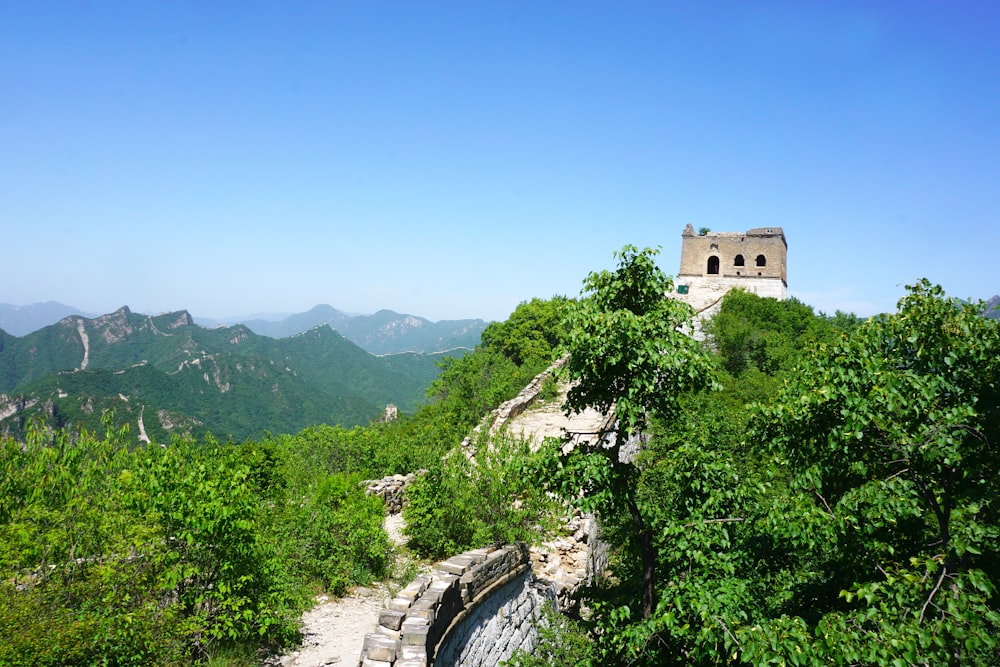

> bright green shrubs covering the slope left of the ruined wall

[{"left": 0, "top": 299, "right": 564, "bottom": 666}]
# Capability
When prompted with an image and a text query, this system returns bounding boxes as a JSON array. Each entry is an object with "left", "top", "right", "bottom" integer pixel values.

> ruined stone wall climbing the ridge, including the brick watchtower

[{"left": 281, "top": 225, "right": 787, "bottom": 667}]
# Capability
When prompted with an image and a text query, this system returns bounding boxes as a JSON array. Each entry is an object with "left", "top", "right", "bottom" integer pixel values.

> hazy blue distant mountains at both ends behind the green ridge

[{"left": 0, "top": 301, "right": 488, "bottom": 354}]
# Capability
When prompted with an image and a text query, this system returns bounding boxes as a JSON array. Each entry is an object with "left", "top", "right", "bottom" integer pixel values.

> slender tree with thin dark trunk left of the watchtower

[{"left": 554, "top": 246, "right": 713, "bottom": 617}]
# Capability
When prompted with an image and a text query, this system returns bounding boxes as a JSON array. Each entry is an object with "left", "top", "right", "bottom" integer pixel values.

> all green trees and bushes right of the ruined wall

[{"left": 519, "top": 248, "right": 1000, "bottom": 665}]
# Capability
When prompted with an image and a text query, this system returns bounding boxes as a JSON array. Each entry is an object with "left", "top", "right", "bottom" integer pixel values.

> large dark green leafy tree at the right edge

[{"left": 734, "top": 280, "right": 1000, "bottom": 664}]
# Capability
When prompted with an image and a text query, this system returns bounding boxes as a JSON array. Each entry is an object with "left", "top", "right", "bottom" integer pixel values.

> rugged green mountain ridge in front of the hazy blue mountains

[{"left": 0, "top": 307, "right": 440, "bottom": 442}]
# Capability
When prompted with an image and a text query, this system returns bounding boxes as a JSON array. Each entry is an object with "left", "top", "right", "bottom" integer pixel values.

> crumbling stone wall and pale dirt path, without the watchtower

[{"left": 269, "top": 359, "right": 609, "bottom": 667}]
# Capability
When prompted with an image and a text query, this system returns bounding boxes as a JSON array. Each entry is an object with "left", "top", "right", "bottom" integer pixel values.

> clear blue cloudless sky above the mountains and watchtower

[{"left": 0, "top": 0, "right": 1000, "bottom": 320}]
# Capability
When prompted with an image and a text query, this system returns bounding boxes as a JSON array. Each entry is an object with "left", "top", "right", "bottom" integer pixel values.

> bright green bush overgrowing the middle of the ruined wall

[{"left": 403, "top": 435, "right": 556, "bottom": 558}]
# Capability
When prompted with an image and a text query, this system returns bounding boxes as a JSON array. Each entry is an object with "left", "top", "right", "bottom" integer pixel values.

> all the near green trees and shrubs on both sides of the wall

[{"left": 0, "top": 246, "right": 1000, "bottom": 666}]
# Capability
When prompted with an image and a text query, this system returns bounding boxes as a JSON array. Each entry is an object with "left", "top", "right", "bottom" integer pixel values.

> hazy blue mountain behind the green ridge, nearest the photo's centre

[{"left": 199, "top": 304, "right": 487, "bottom": 354}]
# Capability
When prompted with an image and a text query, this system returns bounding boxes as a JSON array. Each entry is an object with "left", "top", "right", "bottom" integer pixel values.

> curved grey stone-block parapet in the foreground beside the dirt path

[{"left": 359, "top": 543, "right": 553, "bottom": 667}]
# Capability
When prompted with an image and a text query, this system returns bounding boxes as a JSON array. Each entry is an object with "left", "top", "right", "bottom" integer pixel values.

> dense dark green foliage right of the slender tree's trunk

[{"left": 594, "top": 281, "right": 1000, "bottom": 665}]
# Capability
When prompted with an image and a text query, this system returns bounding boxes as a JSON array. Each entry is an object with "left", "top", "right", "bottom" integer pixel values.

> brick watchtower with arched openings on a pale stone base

[{"left": 673, "top": 225, "right": 788, "bottom": 317}]
